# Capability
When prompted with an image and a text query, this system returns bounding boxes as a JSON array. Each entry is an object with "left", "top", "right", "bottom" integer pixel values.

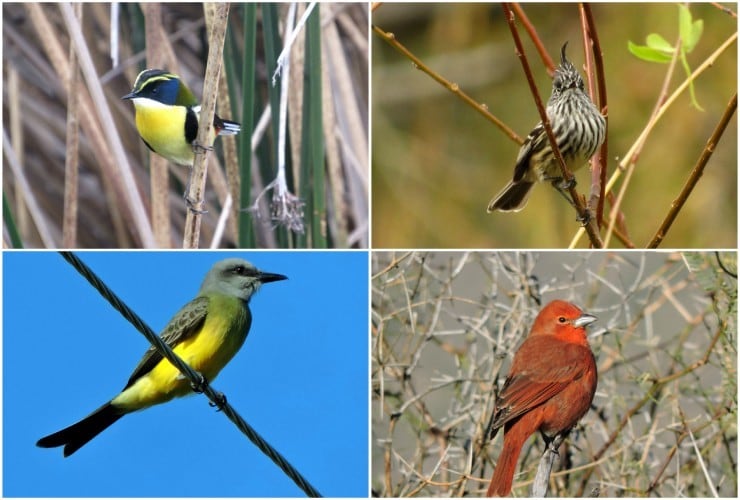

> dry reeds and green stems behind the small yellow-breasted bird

[{"left": 3, "top": 3, "right": 369, "bottom": 248}]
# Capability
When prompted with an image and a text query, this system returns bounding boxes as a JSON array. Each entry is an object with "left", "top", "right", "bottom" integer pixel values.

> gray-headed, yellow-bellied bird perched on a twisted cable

[{"left": 36, "top": 258, "right": 287, "bottom": 457}]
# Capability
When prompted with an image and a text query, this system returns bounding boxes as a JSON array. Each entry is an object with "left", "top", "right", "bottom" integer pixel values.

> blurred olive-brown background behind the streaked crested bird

[{"left": 371, "top": 3, "right": 737, "bottom": 248}]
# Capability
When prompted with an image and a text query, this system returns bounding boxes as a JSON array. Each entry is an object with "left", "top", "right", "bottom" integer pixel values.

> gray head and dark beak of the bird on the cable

[{"left": 200, "top": 258, "right": 288, "bottom": 302}]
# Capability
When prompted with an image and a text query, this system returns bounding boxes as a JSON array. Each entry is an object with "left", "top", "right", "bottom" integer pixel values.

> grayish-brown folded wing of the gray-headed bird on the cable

[{"left": 123, "top": 297, "right": 208, "bottom": 390}]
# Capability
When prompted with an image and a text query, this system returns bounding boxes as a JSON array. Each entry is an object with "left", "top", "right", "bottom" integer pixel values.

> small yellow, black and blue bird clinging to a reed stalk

[{"left": 121, "top": 69, "right": 241, "bottom": 171}]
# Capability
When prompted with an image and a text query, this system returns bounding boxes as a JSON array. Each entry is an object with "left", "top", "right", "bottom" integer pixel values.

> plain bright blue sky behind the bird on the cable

[{"left": 3, "top": 251, "right": 369, "bottom": 497}]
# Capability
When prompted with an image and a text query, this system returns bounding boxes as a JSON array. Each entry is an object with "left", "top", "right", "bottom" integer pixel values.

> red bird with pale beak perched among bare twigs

[{"left": 487, "top": 300, "right": 596, "bottom": 497}]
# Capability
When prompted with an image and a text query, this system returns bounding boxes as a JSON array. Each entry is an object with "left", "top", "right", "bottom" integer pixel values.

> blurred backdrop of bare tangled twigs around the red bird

[{"left": 371, "top": 251, "right": 738, "bottom": 498}]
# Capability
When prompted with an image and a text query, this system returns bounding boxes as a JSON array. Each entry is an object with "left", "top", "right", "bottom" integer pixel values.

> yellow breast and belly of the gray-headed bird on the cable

[{"left": 111, "top": 296, "right": 251, "bottom": 411}]
